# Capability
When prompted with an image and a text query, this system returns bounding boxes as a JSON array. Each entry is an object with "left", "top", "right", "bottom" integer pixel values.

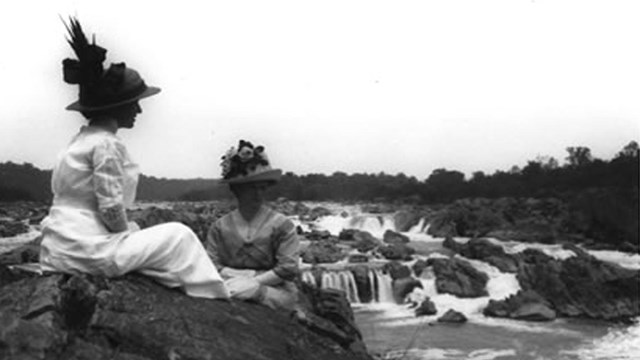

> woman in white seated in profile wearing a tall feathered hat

[{"left": 40, "top": 19, "right": 229, "bottom": 298}]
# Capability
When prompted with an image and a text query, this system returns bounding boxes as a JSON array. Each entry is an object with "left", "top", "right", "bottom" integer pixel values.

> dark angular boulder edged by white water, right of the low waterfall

[{"left": 427, "top": 258, "right": 489, "bottom": 298}]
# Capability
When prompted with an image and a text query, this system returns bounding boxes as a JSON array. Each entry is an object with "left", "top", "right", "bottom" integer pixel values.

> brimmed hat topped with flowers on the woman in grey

[{"left": 220, "top": 140, "right": 282, "bottom": 184}]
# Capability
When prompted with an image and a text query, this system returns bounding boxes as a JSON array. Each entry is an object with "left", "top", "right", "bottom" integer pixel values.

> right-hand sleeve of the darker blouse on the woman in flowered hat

[{"left": 273, "top": 220, "right": 300, "bottom": 280}]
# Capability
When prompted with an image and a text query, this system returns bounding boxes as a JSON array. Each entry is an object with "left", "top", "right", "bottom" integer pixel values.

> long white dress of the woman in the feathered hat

[{"left": 40, "top": 126, "right": 229, "bottom": 298}]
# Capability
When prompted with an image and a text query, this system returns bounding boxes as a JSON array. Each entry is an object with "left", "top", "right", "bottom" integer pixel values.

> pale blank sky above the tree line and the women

[{"left": 0, "top": 0, "right": 640, "bottom": 179}]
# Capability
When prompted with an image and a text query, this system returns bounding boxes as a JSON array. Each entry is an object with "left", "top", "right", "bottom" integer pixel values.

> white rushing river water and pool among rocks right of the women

[{"left": 301, "top": 204, "right": 640, "bottom": 360}]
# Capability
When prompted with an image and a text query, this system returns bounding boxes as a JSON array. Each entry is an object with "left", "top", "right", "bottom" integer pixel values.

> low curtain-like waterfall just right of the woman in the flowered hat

[{"left": 302, "top": 269, "right": 394, "bottom": 304}]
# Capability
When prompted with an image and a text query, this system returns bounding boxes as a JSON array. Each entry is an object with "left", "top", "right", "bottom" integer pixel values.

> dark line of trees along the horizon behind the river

[{"left": 0, "top": 141, "right": 640, "bottom": 207}]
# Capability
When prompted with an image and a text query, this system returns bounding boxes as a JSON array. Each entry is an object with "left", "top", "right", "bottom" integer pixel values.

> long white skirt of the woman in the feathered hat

[{"left": 40, "top": 215, "right": 229, "bottom": 299}]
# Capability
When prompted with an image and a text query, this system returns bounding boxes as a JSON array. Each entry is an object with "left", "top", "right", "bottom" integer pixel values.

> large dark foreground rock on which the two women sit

[{"left": 0, "top": 268, "right": 369, "bottom": 360}]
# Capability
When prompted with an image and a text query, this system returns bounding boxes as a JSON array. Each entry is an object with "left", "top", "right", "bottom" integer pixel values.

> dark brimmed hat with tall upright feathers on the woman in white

[{"left": 62, "top": 18, "right": 160, "bottom": 112}]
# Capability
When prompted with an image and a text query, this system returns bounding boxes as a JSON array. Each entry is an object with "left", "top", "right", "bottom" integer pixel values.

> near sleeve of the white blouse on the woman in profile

[{"left": 92, "top": 139, "right": 128, "bottom": 232}]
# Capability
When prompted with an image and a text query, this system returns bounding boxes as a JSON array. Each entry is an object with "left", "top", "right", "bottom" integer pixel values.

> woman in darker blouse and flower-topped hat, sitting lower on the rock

[{"left": 205, "top": 140, "right": 300, "bottom": 309}]
